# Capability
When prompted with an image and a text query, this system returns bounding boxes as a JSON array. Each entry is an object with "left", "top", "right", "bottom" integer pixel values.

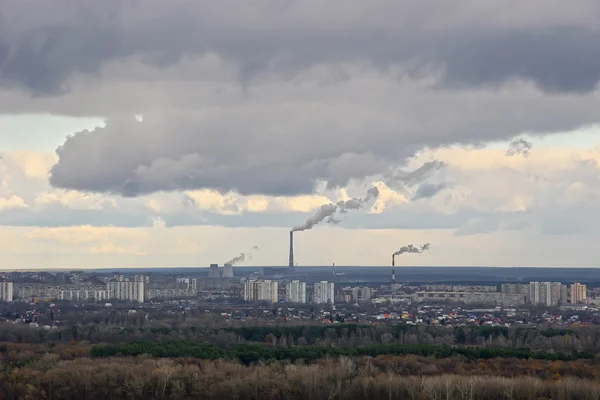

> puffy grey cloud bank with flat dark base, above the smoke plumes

[{"left": 50, "top": 115, "right": 420, "bottom": 197}]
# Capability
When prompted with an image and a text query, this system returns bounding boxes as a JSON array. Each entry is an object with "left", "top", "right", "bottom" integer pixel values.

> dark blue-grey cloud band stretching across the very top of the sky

[{"left": 0, "top": 0, "right": 600, "bottom": 94}]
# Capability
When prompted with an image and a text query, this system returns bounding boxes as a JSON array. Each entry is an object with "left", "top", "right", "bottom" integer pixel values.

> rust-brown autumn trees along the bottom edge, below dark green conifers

[{"left": 0, "top": 357, "right": 600, "bottom": 400}]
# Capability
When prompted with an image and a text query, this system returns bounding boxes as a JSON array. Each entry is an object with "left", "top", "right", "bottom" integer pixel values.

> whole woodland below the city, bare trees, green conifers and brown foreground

[{"left": 0, "top": 312, "right": 600, "bottom": 399}]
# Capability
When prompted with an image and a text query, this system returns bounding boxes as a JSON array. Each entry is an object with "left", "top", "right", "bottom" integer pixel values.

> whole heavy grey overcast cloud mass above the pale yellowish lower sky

[{"left": 0, "top": 0, "right": 600, "bottom": 196}]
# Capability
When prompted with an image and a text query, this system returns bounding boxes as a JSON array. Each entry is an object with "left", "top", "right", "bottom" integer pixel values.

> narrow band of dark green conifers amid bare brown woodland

[{"left": 90, "top": 341, "right": 594, "bottom": 364}]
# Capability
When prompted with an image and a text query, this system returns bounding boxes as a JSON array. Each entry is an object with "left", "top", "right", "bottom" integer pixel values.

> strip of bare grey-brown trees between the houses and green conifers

[{"left": 0, "top": 323, "right": 600, "bottom": 352}]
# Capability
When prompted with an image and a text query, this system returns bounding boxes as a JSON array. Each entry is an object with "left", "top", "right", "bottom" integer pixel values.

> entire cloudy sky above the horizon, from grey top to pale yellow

[{"left": 0, "top": 0, "right": 600, "bottom": 269}]
